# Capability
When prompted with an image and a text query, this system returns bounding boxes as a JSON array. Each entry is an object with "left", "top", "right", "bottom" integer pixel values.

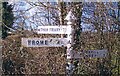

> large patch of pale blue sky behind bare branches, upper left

[{"left": 9, "top": 0, "right": 51, "bottom": 29}]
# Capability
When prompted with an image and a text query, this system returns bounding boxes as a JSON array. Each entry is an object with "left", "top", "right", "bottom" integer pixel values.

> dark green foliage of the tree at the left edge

[{"left": 2, "top": 2, "right": 14, "bottom": 39}]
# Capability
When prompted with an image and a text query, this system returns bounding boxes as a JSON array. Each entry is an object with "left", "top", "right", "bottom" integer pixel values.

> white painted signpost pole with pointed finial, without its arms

[{"left": 65, "top": 10, "right": 75, "bottom": 74}]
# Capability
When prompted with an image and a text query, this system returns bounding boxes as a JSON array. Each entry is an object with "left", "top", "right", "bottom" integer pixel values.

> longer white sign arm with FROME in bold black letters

[{"left": 22, "top": 38, "right": 68, "bottom": 47}]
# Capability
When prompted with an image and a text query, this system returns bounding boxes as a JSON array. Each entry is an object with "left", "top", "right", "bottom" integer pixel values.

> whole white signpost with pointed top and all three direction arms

[{"left": 22, "top": 8, "right": 108, "bottom": 74}]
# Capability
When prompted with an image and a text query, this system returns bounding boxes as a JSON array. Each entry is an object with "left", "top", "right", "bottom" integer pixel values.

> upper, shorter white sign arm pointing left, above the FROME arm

[{"left": 35, "top": 26, "right": 71, "bottom": 34}]
